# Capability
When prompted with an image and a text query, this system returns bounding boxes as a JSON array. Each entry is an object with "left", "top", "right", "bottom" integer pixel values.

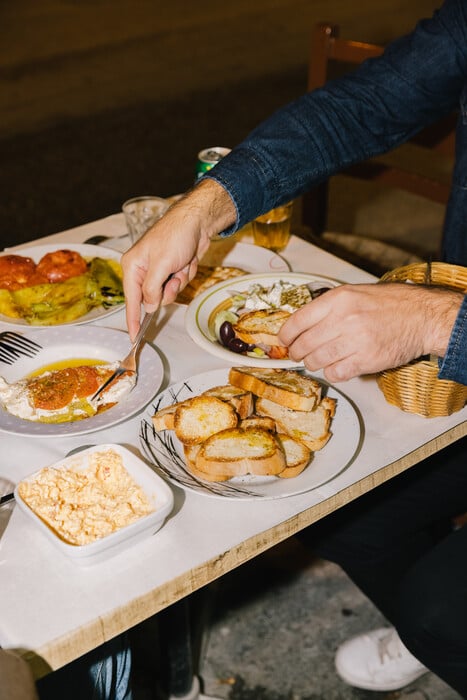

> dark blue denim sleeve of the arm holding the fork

[{"left": 206, "top": 0, "right": 467, "bottom": 235}]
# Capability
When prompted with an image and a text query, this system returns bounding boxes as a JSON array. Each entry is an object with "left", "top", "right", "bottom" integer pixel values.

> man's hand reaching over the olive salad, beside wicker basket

[{"left": 279, "top": 283, "right": 463, "bottom": 382}]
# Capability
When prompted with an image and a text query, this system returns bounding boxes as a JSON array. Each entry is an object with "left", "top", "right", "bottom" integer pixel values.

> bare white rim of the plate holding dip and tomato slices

[{"left": 0, "top": 326, "right": 164, "bottom": 438}]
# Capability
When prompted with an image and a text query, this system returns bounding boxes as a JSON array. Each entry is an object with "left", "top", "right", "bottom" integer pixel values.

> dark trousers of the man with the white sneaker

[{"left": 299, "top": 438, "right": 467, "bottom": 698}]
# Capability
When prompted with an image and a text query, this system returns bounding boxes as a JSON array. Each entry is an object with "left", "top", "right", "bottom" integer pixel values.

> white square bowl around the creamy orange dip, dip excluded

[{"left": 15, "top": 443, "right": 174, "bottom": 566}]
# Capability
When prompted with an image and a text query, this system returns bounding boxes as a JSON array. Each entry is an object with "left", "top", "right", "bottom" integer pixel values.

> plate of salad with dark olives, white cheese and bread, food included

[{"left": 185, "top": 272, "right": 341, "bottom": 368}]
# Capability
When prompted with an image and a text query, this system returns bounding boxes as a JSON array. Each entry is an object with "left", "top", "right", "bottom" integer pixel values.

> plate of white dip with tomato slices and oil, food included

[{"left": 0, "top": 326, "right": 164, "bottom": 437}]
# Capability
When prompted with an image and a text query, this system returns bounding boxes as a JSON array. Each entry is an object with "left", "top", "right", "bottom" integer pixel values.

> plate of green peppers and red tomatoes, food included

[{"left": 0, "top": 243, "right": 125, "bottom": 327}]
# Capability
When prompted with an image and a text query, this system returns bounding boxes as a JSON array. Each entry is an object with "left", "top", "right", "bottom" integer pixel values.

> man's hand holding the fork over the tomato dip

[{"left": 122, "top": 180, "right": 236, "bottom": 339}]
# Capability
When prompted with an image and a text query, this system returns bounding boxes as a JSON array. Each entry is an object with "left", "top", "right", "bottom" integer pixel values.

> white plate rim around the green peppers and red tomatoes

[{"left": 0, "top": 243, "right": 123, "bottom": 328}]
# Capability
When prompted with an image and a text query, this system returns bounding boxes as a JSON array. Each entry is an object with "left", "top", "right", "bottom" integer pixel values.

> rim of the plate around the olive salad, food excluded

[{"left": 185, "top": 272, "right": 342, "bottom": 367}]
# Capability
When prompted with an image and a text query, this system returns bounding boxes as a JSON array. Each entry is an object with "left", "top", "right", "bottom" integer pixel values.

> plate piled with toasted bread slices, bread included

[{"left": 140, "top": 366, "right": 362, "bottom": 499}]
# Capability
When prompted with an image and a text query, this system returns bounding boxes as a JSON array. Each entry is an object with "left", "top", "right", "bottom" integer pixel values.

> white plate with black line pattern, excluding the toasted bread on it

[{"left": 140, "top": 368, "right": 362, "bottom": 499}]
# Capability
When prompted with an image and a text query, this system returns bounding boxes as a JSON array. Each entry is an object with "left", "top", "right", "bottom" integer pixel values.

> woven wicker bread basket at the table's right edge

[{"left": 377, "top": 262, "right": 467, "bottom": 418}]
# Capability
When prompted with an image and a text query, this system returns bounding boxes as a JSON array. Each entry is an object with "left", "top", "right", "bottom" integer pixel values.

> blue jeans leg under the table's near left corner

[{"left": 37, "top": 635, "right": 132, "bottom": 700}]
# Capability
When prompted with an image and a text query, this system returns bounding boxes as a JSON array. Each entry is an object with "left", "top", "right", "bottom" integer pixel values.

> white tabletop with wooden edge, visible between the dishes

[{"left": 0, "top": 214, "right": 467, "bottom": 676}]
